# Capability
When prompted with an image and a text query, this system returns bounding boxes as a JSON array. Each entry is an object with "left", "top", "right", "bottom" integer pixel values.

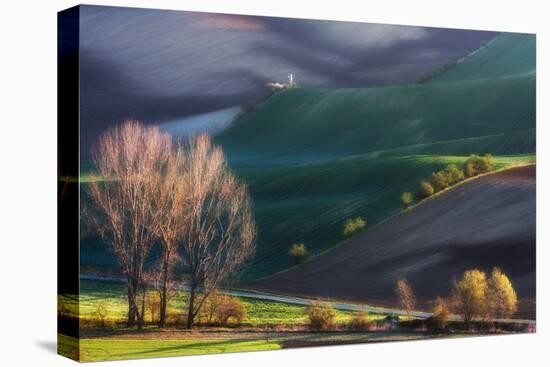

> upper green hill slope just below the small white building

[{"left": 217, "top": 34, "right": 535, "bottom": 161}]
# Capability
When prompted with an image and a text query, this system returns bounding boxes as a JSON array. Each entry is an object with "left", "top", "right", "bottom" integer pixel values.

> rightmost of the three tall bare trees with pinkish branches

[{"left": 178, "top": 135, "right": 256, "bottom": 328}]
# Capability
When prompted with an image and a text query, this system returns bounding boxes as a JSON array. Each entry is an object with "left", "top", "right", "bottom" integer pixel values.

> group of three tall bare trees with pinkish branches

[{"left": 88, "top": 121, "right": 256, "bottom": 328}]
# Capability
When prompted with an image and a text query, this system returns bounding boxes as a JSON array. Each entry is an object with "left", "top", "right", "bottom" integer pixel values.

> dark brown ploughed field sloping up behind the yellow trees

[{"left": 252, "top": 165, "right": 536, "bottom": 317}]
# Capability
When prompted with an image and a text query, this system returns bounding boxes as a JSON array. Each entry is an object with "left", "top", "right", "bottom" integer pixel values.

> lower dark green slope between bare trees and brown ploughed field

[{"left": 237, "top": 155, "right": 534, "bottom": 278}]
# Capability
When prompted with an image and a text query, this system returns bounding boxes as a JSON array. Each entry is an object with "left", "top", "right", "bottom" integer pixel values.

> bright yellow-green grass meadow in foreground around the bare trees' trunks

[{"left": 58, "top": 280, "right": 410, "bottom": 362}]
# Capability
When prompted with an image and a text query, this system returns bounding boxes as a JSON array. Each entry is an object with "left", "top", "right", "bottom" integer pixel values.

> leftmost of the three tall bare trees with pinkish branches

[{"left": 89, "top": 121, "right": 172, "bottom": 326}]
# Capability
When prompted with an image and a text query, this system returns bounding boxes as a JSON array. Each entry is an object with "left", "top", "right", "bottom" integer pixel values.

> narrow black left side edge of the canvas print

[{"left": 57, "top": 6, "right": 80, "bottom": 360}]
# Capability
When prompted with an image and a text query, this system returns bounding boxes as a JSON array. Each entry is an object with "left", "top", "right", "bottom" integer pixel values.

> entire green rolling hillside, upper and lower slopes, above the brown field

[{"left": 81, "top": 34, "right": 536, "bottom": 280}]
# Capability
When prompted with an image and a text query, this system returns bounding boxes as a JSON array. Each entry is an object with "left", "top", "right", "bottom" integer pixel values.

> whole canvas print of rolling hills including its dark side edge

[{"left": 57, "top": 5, "right": 536, "bottom": 361}]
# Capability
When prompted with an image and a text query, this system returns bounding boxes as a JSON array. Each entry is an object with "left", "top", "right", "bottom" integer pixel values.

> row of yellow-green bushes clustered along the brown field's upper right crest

[{"left": 401, "top": 154, "right": 494, "bottom": 207}]
